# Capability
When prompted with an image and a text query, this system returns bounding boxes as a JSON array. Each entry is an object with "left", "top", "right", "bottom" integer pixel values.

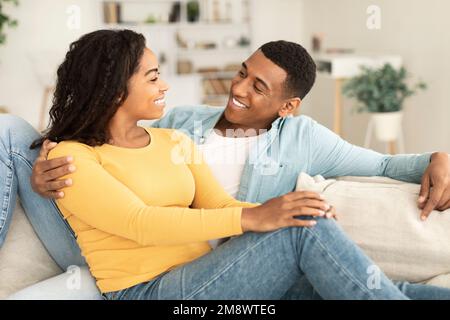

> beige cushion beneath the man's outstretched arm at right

[{"left": 297, "top": 173, "right": 450, "bottom": 287}]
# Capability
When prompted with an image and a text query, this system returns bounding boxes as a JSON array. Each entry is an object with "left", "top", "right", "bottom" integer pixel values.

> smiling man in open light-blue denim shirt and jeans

[{"left": 0, "top": 41, "right": 450, "bottom": 298}]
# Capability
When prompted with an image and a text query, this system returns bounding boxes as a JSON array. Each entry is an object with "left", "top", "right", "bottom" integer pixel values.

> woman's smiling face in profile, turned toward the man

[{"left": 118, "top": 48, "right": 169, "bottom": 120}]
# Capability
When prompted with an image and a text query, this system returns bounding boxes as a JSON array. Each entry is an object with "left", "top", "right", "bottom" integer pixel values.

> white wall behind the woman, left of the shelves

[{"left": 0, "top": 0, "right": 97, "bottom": 126}]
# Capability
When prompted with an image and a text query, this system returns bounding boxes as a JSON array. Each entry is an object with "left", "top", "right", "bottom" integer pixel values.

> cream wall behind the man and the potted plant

[{"left": 303, "top": 0, "right": 450, "bottom": 153}]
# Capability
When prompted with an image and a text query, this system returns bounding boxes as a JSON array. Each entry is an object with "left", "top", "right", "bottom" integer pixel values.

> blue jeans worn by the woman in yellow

[{"left": 103, "top": 217, "right": 450, "bottom": 300}]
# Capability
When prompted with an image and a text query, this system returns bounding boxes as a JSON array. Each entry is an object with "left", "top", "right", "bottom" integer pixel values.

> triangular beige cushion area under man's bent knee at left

[{"left": 0, "top": 203, "right": 62, "bottom": 299}]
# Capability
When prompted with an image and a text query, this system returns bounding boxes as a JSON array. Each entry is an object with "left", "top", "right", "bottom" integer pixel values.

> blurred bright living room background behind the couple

[{"left": 0, "top": 0, "right": 450, "bottom": 153}]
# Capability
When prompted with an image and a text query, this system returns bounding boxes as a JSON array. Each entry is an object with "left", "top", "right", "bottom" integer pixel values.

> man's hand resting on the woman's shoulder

[{"left": 30, "top": 140, "right": 75, "bottom": 199}]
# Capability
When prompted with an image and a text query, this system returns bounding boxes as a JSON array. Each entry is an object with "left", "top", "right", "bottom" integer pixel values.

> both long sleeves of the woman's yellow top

[{"left": 48, "top": 137, "right": 255, "bottom": 245}]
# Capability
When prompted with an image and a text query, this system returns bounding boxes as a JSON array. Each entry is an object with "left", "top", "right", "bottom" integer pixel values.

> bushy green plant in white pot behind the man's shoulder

[{"left": 342, "top": 64, "right": 426, "bottom": 141}]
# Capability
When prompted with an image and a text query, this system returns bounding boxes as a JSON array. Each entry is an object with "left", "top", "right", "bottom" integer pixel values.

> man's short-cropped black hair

[{"left": 259, "top": 40, "right": 316, "bottom": 99}]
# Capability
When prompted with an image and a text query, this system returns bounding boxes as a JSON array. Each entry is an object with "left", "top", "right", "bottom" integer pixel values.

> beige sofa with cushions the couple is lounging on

[{"left": 0, "top": 173, "right": 450, "bottom": 299}]
